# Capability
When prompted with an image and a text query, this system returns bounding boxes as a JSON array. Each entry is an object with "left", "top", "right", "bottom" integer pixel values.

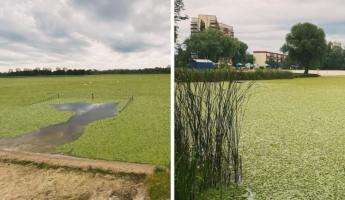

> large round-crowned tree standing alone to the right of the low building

[{"left": 281, "top": 23, "right": 327, "bottom": 74}]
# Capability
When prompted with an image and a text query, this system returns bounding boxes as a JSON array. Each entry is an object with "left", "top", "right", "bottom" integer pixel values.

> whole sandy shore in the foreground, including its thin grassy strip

[{"left": 0, "top": 151, "right": 155, "bottom": 200}]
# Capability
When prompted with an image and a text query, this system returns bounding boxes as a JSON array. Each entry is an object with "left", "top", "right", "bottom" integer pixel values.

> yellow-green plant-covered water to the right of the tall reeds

[{"left": 241, "top": 77, "right": 345, "bottom": 199}]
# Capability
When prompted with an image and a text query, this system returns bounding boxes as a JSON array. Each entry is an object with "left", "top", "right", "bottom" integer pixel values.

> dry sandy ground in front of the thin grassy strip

[{"left": 0, "top": 162, "right": 147, "bottom": 200}]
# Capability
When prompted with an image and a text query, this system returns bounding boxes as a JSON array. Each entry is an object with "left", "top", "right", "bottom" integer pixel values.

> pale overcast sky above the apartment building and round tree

[{"left": 180, "top": 0, "right": 345, "bottom": 52}]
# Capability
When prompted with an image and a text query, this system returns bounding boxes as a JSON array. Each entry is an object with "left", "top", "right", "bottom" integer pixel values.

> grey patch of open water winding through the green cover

[{"left": 0, "top": 103, "right": 117, "bottom": 153}]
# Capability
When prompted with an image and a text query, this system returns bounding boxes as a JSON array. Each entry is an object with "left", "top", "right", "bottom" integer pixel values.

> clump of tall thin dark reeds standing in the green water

[{"left": 175, "top": 74, "right": 253, "bottom": 200}]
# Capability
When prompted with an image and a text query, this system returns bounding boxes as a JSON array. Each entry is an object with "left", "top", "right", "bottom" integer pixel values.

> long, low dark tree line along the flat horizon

[{"left": 0, "top": 67, "right": 170, "bottom": 77}]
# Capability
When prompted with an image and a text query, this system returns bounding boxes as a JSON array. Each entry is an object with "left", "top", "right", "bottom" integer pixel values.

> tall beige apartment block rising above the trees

[{"left": 191, "top": 15, "right": 234, "bottom": 37}]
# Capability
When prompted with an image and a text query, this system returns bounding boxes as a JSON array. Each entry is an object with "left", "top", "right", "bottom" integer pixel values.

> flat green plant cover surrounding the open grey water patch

[{"left": 0, "top": 75, "right": 170, "bottom": 165}]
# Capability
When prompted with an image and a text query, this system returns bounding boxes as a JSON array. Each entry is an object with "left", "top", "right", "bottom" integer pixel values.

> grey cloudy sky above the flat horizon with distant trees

[{"left": 0, "top": 0, "right": 170, "bottom": 71}]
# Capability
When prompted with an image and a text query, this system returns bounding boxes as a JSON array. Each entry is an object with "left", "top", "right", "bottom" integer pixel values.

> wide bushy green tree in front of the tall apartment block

[{"left": 184, "top": 29, "right": 244, "bottom": 62}]
